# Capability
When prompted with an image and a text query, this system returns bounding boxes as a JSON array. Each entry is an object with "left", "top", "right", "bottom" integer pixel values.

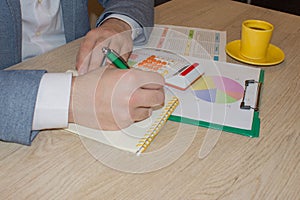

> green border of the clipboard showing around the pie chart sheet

[{"left": 169, "top": 69, "right": 265, "bottom": 138}]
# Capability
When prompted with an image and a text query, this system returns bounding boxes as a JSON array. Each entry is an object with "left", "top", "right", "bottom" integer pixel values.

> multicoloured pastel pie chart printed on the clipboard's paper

[{"left": 191, "top": 76, "right": 244, "bottom": 104}]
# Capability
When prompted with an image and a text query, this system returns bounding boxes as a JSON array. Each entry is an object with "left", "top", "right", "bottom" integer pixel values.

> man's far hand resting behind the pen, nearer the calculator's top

[{"left": 76, "top": 18, "right": 133, "bottom": 75}]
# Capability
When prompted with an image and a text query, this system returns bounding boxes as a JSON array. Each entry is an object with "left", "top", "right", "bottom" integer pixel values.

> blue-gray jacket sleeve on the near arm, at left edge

[{"left": 0, "top": 70, "right": 45, "bottom": 145}]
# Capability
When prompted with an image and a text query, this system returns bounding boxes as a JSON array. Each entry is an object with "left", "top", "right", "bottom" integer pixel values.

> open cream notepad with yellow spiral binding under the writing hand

[{"left": 66, "top": 92, "right": 179, "bottom": 155}]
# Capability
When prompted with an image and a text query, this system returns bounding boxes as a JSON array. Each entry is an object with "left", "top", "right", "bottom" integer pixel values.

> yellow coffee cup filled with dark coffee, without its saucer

[{"left": 240, "top": 20, "right": 274, "bottom": 59}]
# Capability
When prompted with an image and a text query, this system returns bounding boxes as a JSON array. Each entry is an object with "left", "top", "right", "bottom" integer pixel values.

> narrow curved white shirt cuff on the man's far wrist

[{"left": 102, "top": 14, "right": 143, "bottom": 40}]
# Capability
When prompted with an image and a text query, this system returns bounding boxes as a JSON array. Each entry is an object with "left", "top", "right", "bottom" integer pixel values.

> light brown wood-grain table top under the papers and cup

[{"left": 0, "top": 0, "right": 300, "bottom": 200}]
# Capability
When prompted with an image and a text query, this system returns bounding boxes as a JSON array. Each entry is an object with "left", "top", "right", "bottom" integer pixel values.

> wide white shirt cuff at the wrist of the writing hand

[{"left": 32, "top": 73, "right": 72, "bottom": 130}]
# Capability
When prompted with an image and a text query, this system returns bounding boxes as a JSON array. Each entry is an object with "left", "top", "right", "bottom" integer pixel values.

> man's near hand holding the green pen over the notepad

[{"left": 69, "top": 67, "right": 164, "bottom": 130}]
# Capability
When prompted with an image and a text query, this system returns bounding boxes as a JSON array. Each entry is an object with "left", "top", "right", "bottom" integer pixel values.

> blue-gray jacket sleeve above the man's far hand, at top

[{"left": 96, "top": 0, "right": 154, "bottom": 45}]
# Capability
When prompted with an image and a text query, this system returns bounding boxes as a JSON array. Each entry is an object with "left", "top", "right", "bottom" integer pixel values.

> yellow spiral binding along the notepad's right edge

[{"left": 136, "top": 96, "right": 179, "bottom": 155}]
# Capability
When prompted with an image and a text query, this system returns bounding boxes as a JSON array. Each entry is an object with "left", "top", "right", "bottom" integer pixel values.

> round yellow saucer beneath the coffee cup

[{"left": 226, "top": 40, "right": 284, "bottom": 65}]
